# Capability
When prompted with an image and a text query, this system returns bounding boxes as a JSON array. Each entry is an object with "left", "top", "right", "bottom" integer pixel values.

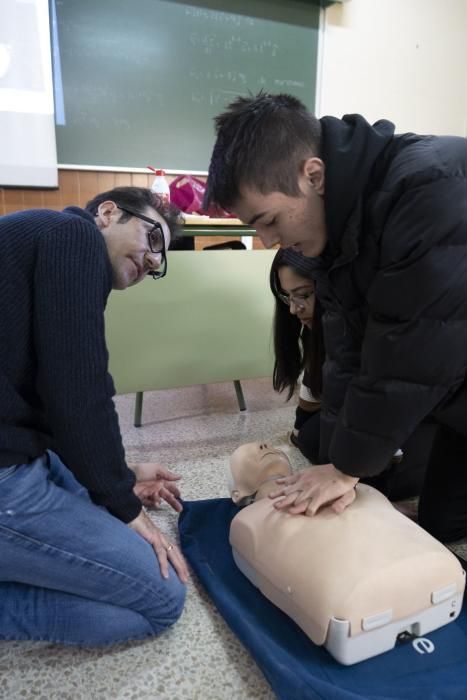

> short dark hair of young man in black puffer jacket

[{"left": 203, "top": 93, "right": 321, "bottom": 209}]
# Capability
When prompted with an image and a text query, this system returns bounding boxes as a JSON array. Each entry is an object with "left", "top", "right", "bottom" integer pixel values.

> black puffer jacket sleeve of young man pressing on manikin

[{"left": 330, "top": 175, "right": 467, "bottom": 476}]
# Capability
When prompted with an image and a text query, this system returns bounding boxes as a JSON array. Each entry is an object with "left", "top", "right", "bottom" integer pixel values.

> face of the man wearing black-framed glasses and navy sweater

[{"left": 96, "top": 201, "right": 170, "bottom": 289}]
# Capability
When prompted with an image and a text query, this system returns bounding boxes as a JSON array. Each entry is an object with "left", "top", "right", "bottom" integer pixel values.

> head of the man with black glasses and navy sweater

[{"left": 86, "top": 187, "right": 178, "bottom": 289}]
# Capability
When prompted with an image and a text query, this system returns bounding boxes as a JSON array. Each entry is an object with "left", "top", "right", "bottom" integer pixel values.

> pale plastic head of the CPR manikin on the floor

[{"left": 228, "top": 442, "right": 292, "bottom": 506}]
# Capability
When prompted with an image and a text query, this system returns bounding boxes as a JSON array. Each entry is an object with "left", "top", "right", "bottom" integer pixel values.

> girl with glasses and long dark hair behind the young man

[{"left": 269, "top": 248, "right": 435, "bottom": 500}]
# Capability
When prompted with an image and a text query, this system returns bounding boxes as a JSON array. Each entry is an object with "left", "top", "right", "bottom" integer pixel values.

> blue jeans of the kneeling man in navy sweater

[{"left": 0, "top": 452, "right": 185, "bottom": 645}]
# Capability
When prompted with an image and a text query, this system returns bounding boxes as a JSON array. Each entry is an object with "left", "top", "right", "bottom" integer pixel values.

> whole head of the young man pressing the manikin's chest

[{"left": 204, "top": 93, "right": 327, "bottom": 257}]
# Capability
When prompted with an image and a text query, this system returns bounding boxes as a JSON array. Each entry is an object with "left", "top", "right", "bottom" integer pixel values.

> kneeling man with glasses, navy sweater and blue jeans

[{"left": 0, "top": 187, "right": 188, "bottom": 645}]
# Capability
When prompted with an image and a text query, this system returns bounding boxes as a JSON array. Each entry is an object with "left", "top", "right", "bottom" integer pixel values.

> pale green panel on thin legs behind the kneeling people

[{"left": 106, "top": 250, "right": 275, "bottom": 394}]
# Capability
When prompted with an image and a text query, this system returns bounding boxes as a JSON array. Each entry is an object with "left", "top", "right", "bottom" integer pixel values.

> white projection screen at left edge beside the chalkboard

[{"left": 0, "top": 0, "right": 57, "bottom": 187}]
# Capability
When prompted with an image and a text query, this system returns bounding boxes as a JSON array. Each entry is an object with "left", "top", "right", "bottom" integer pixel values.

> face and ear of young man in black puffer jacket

[{"left": 233, "top": 158, "right": 327, "bottom": 258}]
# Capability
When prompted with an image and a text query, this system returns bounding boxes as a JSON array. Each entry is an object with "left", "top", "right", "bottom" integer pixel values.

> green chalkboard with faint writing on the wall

[{"left": 55, "top": 0, "right": 319, "bottom": 171}]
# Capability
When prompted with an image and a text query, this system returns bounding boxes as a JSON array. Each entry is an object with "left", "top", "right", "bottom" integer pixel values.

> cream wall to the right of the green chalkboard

[{"left": 317, "top": 0, "right": 467, "bottom": 136}]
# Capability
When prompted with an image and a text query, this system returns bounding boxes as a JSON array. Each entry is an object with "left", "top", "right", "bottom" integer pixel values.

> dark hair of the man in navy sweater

[{"left": 85, "top": 187, "right": 180, "bottom": 240}]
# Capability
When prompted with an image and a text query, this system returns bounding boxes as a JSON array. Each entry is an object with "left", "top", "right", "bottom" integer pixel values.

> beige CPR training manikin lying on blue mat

[{"left": 230, "top": 443, "right": 465, "bottom": 664}]
